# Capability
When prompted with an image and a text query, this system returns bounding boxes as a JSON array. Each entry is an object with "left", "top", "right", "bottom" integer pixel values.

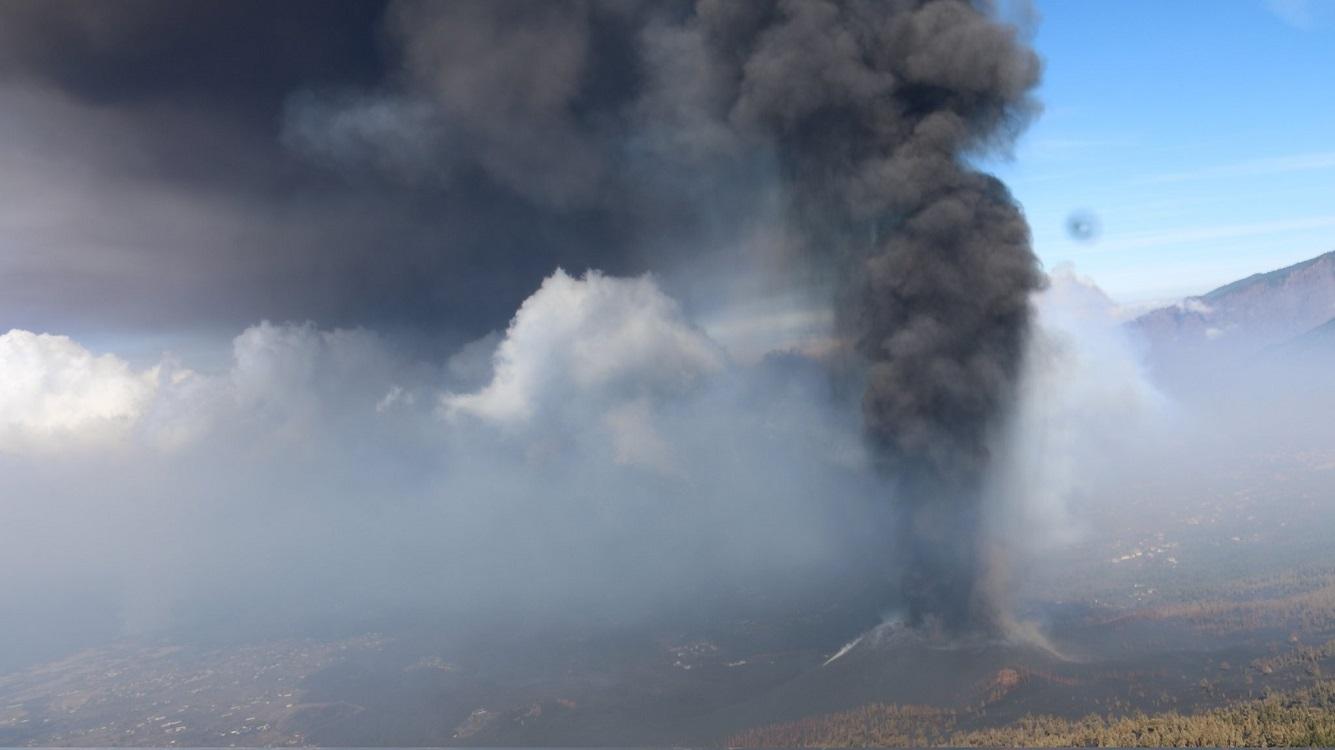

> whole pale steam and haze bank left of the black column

[{"left": 0, "top": 271, "right": 884, "bottom": 653}]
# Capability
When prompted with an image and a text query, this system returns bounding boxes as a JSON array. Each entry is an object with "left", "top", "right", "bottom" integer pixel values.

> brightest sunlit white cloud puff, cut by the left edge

[{"left": 0, "top": 330, "right": 159, "bottom": 450}]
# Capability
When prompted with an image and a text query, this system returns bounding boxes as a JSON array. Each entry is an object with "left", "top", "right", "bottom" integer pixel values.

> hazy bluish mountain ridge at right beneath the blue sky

[{"left": 1131, "top": 251, "right": 1335, "bottom": 378}]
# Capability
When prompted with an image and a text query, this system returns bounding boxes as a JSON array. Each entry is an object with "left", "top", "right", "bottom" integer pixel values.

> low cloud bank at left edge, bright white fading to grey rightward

[{"left": 0, "top": 322, "right": 415, "bottom": 452}]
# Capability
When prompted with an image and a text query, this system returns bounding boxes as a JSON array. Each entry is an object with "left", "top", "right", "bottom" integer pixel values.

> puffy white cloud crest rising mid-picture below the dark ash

[{"left": 442, "top": 270, "right": 726, "bottom": 426}]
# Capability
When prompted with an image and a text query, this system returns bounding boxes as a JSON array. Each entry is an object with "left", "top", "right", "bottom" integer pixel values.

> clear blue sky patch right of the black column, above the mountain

[{"left": 989, "top": 0, "right": 1335, "bottom": 303}]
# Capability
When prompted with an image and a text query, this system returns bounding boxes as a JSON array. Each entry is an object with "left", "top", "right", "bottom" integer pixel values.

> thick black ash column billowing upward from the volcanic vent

[{"left": 701, "top": 0, "right": 1043, "bottom": 633}]
